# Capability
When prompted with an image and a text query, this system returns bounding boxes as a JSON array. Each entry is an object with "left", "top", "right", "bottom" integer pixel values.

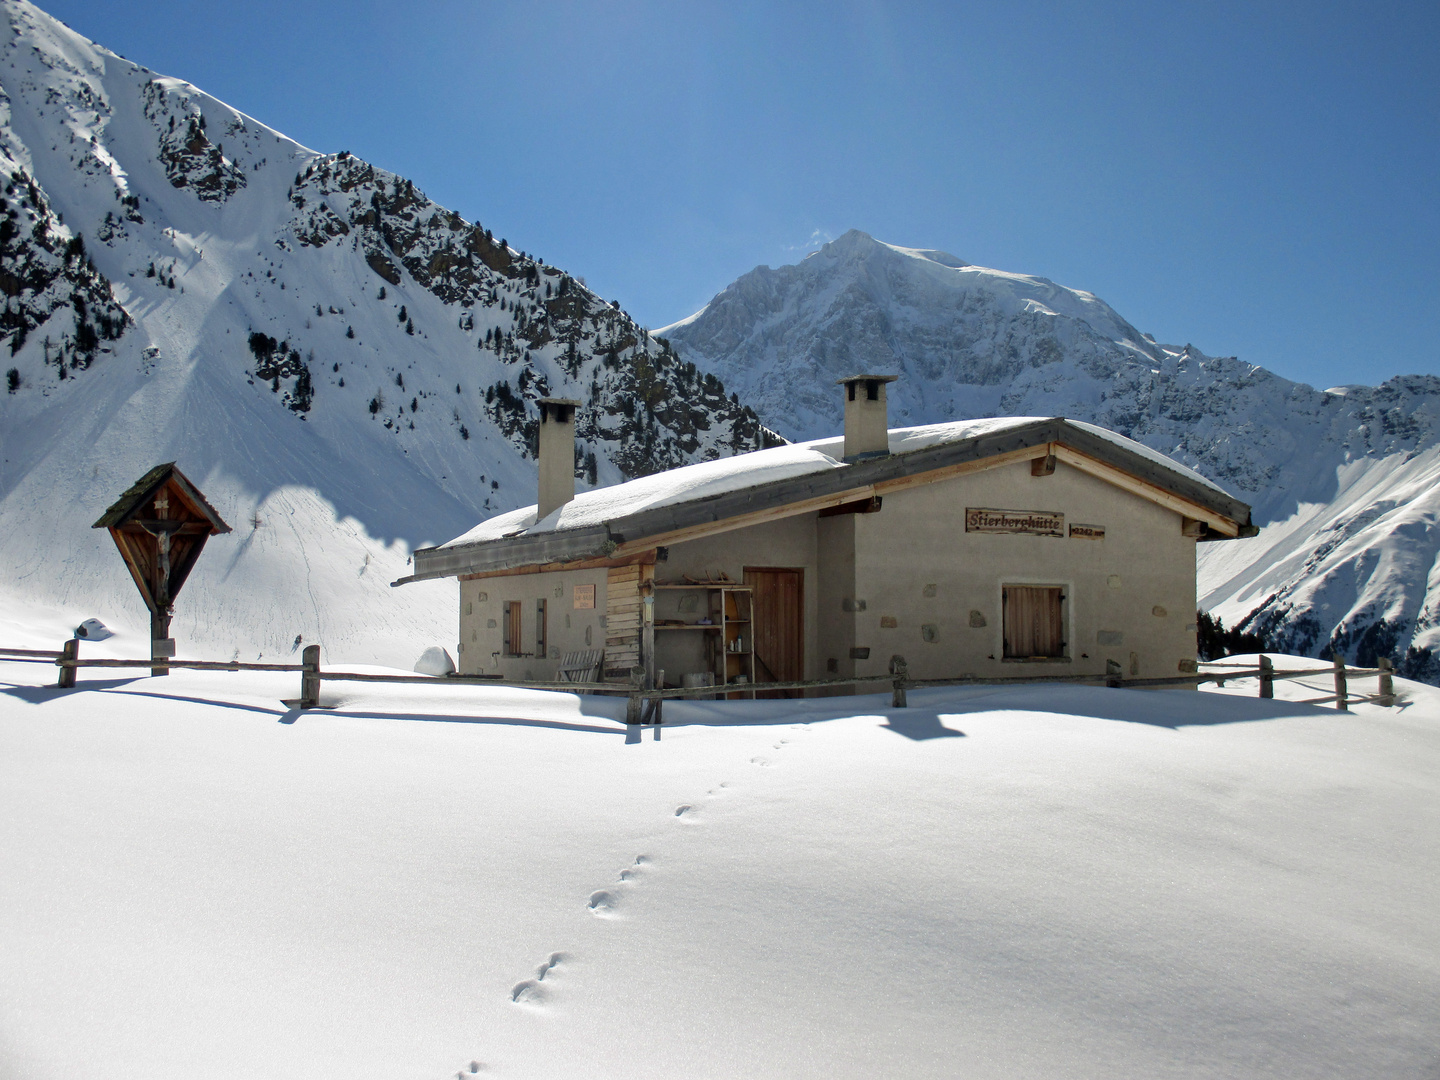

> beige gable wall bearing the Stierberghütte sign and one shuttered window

[{"left": 846, "top": 462, "right": 1195, "bottom": 678}]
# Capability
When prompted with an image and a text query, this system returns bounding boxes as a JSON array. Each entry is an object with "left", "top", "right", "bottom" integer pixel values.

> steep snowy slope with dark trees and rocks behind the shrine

[{"left": 0, "top": 0, "right": 773, "bottom": 662}]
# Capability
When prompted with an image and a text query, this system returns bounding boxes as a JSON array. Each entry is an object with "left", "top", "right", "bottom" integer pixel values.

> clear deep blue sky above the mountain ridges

[{"left": 42, "top": 0, "right": 1440, "bottom": 386}]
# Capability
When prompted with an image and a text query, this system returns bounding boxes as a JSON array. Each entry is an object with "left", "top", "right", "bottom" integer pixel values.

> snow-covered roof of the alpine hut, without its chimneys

[{"left": 405, "top": 416, "right": 1250, "bottom": 580}]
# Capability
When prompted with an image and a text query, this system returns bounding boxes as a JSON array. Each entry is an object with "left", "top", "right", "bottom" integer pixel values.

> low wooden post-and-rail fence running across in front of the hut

[{"left": 0, "top": 648, "right": 1395, "bottom": 724}]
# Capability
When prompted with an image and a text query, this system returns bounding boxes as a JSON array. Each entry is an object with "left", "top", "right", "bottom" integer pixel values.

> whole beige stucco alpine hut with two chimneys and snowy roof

[{"left": 396, "top": 385, "right": 1256, "bottom": 693}]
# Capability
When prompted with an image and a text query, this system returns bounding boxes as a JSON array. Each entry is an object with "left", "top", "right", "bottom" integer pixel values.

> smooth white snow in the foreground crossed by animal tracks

[{"left": 0, "top": 647, "right": 1440, "bottom": 1080}]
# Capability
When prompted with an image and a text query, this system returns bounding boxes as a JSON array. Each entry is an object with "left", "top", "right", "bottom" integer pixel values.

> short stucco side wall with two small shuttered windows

[{"left": 455, "top": 570, "right": 605, "bottom": 680}]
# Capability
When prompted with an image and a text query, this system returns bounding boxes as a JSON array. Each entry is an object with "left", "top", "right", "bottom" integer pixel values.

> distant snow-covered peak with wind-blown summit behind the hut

[{"left": 655, "top": 232, "right": 1440, "bottom": 681}]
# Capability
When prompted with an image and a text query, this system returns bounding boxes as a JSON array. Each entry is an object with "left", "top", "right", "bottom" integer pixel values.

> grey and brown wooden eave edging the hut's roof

[{"left": 393, "top": 418, "right": 1251, "bottom": 585}]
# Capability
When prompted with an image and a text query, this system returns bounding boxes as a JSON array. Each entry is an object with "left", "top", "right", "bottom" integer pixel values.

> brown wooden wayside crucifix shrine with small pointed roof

[{"left": 94, "top": 461, "right": 230, "bottom": 675}]
